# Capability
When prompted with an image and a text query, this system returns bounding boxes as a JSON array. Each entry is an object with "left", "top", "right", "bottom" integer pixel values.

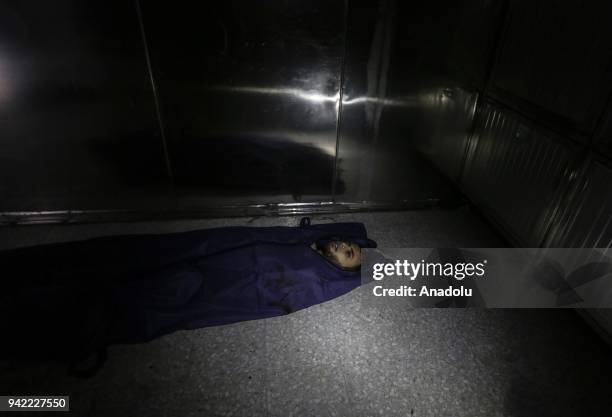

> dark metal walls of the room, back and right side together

[{"left": 0, "top": 0, "right": 612, "bottom": 246}]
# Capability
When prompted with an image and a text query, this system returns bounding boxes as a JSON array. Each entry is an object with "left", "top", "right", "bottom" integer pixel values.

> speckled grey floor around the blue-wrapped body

[{"left": 0, "top": 208, "right": 612, "bottom": 417}]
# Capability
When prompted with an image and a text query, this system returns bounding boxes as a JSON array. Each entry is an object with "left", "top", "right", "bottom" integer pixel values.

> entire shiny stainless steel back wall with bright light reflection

[{"left": 0, "top": 0, "right": 504, "bottom": 222}]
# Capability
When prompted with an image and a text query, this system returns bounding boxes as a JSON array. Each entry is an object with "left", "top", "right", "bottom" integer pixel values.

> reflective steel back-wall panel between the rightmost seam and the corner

[{"left": 336, "top": 0, "right": 501, "bottom": 203}]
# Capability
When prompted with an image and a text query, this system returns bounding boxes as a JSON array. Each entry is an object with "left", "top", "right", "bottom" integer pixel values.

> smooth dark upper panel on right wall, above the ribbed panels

[{"left": 491, "top": 0, "right": 612, "bottom": 141}]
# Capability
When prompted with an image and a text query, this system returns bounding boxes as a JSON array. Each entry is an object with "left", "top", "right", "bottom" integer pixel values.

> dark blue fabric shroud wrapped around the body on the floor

[{"left": 0, "top": 219, "right": 376, "bottom": 358}]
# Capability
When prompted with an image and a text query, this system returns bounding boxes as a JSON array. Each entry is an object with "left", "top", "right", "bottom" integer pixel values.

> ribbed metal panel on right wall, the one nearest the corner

[{"left": 463, "top": 102, "right": 579, "bottom": 247}]
